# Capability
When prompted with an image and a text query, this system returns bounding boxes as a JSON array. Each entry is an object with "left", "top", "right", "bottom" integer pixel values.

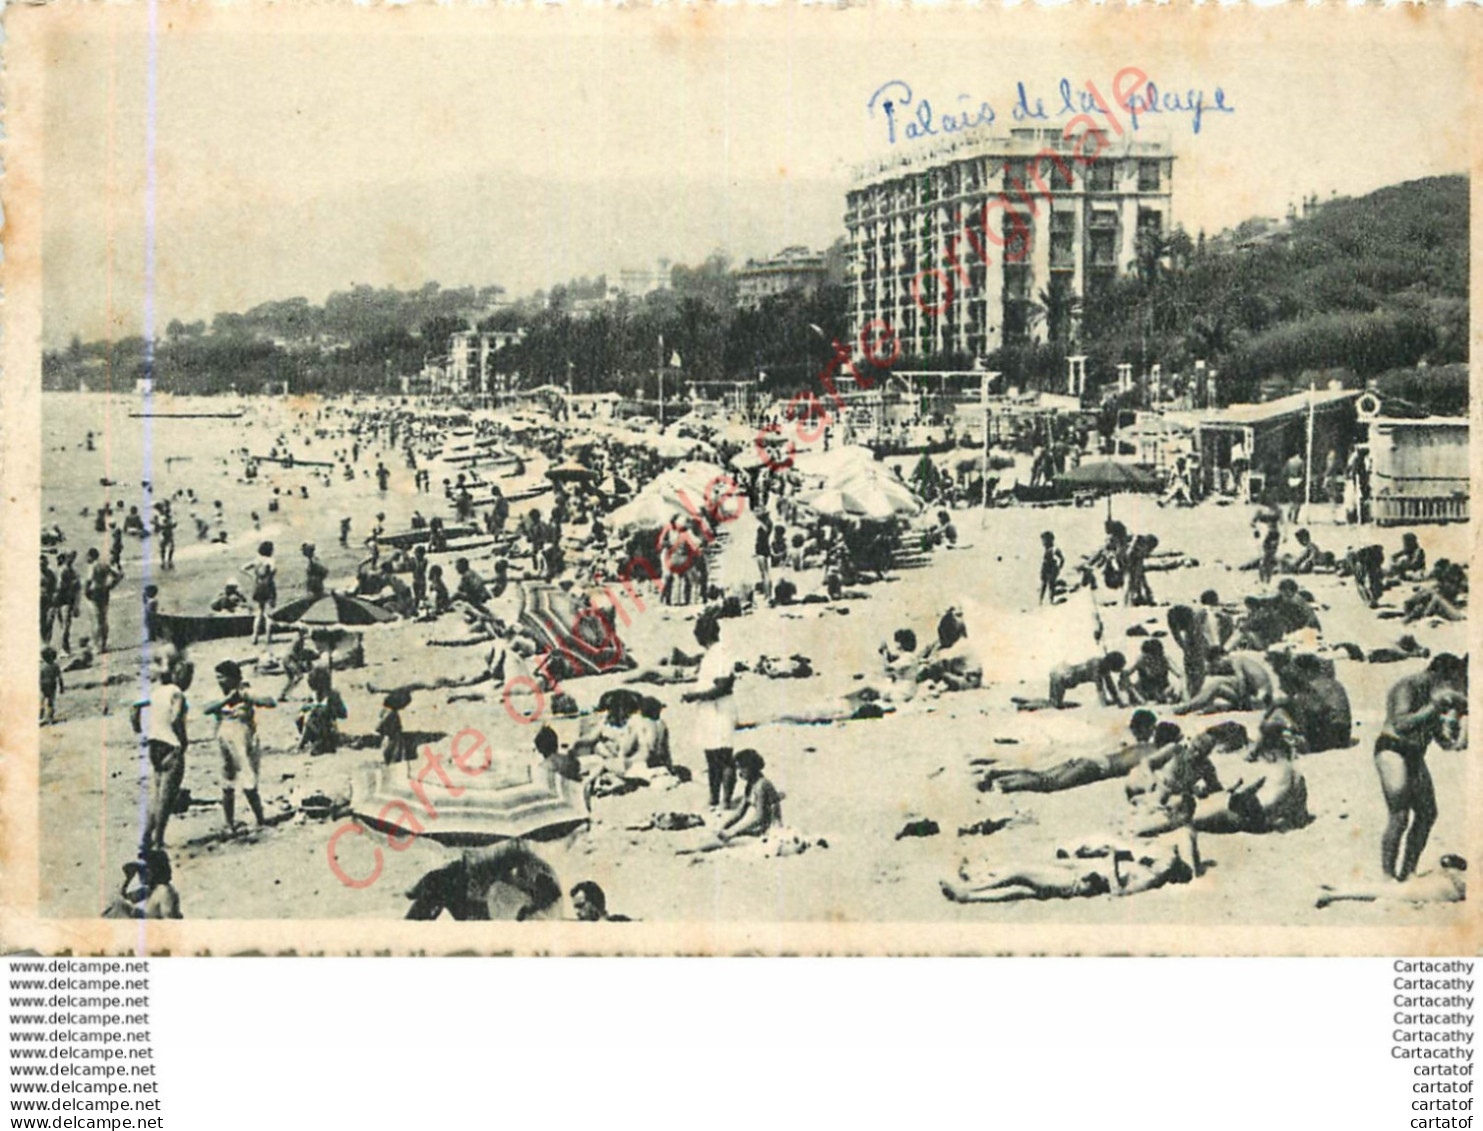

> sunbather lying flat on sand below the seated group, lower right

[{"left": 940, "top": 830, "right": 1201, "bottom": 903}]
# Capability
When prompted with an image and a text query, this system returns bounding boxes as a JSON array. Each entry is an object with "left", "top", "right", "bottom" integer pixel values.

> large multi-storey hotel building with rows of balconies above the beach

[{"left": 845, "top": 129, "right": 1175, "bottom": 357}]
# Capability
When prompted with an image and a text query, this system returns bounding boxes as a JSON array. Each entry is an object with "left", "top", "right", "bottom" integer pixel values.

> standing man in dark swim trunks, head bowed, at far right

[{"left": 1375, "top": 652, "right": 1468, "bottom": 880}]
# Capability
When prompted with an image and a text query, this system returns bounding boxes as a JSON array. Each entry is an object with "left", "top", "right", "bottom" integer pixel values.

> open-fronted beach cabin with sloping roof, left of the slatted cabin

[{"left": 1164, "top": 388, "right": 1360, "bottom": 500}]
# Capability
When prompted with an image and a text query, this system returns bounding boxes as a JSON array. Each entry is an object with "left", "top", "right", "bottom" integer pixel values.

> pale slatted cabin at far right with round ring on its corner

[{"left": 1358, "top": 393, "right": 1470, "bottom": 526}]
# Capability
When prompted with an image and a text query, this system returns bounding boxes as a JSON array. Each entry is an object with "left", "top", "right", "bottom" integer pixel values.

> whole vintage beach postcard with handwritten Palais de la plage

[{"left": 0, "top": 0, "right": 1483, "bottom": 955}]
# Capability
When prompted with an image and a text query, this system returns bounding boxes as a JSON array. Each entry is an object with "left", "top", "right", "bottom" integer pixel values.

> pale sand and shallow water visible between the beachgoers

[{"left": 40, "top": 394, "right": 1467, "bottom": 926}]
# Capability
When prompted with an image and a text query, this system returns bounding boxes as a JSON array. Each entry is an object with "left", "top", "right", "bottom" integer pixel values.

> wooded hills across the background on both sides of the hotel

[{"left": 43, "top": 176, "right": 1468, "bottom": 402}]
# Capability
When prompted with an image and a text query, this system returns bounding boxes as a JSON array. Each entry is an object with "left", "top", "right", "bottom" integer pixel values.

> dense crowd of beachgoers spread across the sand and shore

[{"left": 40, "top": 394, "right": 1467, "bottom": 921}]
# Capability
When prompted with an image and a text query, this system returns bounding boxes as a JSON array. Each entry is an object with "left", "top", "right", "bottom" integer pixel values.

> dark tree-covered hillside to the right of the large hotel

[{"left": 966, "top": 176, "right": 1468, "bottom": 402}]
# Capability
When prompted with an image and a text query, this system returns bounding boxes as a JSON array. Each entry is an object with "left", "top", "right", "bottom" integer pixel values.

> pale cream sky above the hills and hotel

[{"left": 34, "top": 4, "right": 1470, "bottom": 347}]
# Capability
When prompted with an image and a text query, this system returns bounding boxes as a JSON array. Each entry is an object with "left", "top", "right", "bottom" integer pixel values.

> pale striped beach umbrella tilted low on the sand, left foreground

[{"left": 350, "top": 744, "right": 590, "bottom": 845}]
